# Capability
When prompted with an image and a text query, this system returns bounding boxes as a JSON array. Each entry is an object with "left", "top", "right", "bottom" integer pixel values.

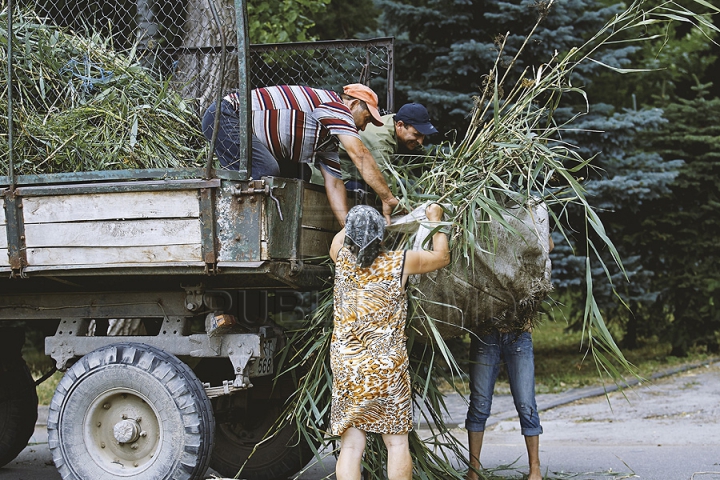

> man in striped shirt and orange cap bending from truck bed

[{"left": 202, "top": 83, "right": 398, "bottom": 225}]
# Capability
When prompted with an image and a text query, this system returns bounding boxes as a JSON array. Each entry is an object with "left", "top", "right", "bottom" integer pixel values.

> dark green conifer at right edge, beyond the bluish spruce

[{"left": 636, "top": 94, "right": 720, "bottom": 355}]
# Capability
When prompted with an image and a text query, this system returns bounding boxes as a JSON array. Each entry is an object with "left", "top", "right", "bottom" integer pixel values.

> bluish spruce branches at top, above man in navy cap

[{"left": 376, "top": 0, "right": 638, "bottom": 133}]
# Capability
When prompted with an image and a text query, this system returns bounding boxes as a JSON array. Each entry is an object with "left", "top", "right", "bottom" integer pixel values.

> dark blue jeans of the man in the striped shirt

[{"left": 202, "top": 100, "right": 311, "bottom": 180}]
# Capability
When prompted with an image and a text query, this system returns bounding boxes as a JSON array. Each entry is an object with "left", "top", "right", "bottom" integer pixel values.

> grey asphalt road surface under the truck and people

[{"left": 0, "top": 363, "right": 720, "bottom": 480}]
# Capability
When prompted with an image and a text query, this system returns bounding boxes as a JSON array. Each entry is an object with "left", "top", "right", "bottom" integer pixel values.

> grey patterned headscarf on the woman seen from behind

[{"left": 345, "top": 205, "right": 385, "bottom": 267}]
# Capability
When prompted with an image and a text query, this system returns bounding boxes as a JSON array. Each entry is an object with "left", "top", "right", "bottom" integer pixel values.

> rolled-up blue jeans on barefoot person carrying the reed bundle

[{"left": 465, "top": 330, "right": 542, "bottom": 437}]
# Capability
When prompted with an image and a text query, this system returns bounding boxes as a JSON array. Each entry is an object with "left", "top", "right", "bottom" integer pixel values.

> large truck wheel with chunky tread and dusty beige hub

[{"left": 48, "top": 343, "right": 215, "bottom": 480}]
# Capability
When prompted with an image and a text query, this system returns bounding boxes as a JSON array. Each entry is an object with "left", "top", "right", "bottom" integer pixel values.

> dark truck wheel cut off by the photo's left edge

[{"left": 0, "top": 357, "right": 38, "bottom": 467}]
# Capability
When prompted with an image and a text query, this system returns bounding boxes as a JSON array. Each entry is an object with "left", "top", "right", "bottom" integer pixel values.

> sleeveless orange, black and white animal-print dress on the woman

[{"left": 330, "top": 247, "right": 412, "bottom": 435}]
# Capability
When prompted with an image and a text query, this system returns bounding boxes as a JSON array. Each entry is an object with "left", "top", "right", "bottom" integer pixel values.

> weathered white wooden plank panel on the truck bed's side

[{"left": 23, "top": 190, "right": 202, "bottom": 268}]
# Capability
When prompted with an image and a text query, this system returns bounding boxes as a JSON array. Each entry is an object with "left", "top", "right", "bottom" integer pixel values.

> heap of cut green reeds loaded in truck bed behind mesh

[{"left": 0, "top": 9, "right": 206, "bottom": 174}]
